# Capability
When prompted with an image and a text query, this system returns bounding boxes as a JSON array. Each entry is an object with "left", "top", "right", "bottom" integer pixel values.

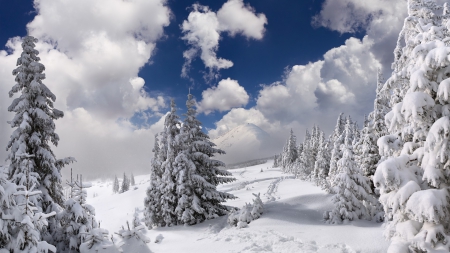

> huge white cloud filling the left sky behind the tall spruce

[{"left": 0, "top": 0, "right": 170, "bottom": 179}]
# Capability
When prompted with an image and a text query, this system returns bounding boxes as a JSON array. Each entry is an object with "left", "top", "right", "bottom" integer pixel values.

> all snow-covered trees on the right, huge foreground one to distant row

[{"left": 276, "top": 0, "right": 450, "bottom": 253}]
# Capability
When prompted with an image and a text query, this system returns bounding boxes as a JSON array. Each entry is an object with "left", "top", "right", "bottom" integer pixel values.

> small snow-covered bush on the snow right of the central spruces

[{"left": 227, "top": 193, "right": 264, "bottom": 228}]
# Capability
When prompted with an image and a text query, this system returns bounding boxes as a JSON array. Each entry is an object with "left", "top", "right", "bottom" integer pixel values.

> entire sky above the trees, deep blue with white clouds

[{"left": 0, "top": 0, "right": 406, "bottom": 178}]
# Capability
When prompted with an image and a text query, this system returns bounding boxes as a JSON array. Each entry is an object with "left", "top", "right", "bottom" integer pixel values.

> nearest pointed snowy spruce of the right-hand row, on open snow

[{"left": 324, "top": 117, "right": 375, "bottom": 224}]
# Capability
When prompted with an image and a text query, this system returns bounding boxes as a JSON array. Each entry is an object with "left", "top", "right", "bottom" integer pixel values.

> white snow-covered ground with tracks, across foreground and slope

[{"left": 88, "top": 160, "right": 388, "bottom": 253}]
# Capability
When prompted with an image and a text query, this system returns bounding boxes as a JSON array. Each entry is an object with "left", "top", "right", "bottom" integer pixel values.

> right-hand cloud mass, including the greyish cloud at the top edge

[{"left": 210, "top": 0, "right": 407, "bottom": 152}]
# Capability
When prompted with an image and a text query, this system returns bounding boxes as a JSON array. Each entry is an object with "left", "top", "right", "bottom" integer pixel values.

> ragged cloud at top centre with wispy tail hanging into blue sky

[{"left": 181, "top": 0, "right": 267, "bottom": 79}]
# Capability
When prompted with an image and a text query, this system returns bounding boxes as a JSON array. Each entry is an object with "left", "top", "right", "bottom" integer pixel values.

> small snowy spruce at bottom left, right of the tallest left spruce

[{"left": 57, "top": 176, "right": 97, "bottom": 252}]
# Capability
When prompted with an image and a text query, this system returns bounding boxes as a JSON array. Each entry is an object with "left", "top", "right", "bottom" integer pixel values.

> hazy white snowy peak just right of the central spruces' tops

[{"left": 212, "top": 123, "right": 273, "bottom": 164}]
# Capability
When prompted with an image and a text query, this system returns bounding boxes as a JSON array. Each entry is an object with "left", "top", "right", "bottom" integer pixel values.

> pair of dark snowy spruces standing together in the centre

[{"left": 144, "top": 94, "right": 235, "bottom": 228}]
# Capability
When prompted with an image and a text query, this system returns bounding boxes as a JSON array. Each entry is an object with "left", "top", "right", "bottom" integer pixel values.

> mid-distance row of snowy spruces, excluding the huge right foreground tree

[{"left": 274, "top": 93, "right": 387, "bottom": 223}]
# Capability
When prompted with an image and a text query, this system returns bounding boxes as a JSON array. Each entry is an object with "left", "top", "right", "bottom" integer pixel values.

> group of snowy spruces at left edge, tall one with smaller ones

[{"left": 0, "top": 36, "right": 121, "bottom": 253}]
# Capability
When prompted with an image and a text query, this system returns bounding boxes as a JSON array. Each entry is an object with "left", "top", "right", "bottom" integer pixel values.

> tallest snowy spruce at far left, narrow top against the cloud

[{"left": 7, "top": 36, "right": 75, "bottom": 241}]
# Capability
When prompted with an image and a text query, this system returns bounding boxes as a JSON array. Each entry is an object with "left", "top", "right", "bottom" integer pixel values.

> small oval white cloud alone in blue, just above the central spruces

[{"left": 198, "top": 78, "right": 249, "bottom": 115}]
